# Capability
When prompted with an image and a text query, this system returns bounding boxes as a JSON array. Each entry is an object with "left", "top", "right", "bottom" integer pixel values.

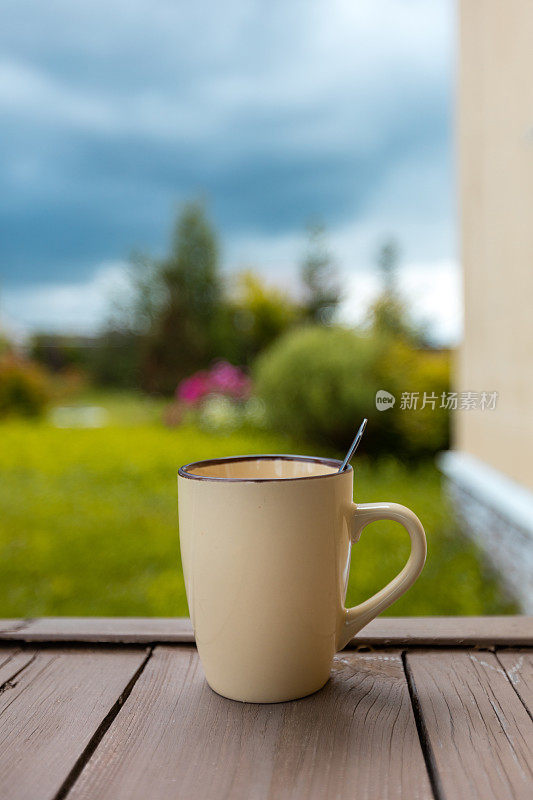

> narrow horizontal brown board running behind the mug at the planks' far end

[{"left": 0, "top": 616, "right": 533, "bottom": 648}]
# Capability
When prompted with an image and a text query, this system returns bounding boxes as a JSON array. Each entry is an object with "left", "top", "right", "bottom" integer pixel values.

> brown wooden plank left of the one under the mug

[{"left": 0, "top": 648, "right": 146, "bottom": 800}]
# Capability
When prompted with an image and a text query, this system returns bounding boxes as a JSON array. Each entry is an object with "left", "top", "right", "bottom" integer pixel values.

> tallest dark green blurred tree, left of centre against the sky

[{"left": 93, "top": 202, "right": 224, "bottom": 394}]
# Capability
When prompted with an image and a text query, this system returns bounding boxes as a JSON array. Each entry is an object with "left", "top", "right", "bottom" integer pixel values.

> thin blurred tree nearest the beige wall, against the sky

[{"left": 368, "top": 238, "right": 426, "bottom": 346}]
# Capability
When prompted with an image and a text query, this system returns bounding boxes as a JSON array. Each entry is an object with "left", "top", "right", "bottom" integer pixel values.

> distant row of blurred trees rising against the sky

[{"left": 31, "top": 197, "right": 424, "bottom": 395}]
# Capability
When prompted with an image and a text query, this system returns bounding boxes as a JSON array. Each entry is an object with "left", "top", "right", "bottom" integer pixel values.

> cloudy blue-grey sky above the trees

[{"left": 0, "top": 0, "right": 459, "bottom": 339}]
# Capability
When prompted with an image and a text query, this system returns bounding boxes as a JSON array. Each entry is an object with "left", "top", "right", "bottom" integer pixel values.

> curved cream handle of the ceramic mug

[{"left": 338, "top": 503, "right": 427, "bottom": 650}]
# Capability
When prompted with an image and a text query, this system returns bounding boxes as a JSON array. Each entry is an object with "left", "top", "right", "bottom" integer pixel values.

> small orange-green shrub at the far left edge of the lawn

[{"left": 0, "top": 357, "right": 49, "bottom": 417}]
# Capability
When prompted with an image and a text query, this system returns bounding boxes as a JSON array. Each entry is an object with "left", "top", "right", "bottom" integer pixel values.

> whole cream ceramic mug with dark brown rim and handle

[{"left": 178, "top": 455, "right": 426, "bottom": 703}]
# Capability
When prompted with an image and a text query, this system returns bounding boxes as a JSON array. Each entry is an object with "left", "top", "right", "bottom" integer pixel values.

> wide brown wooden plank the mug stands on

[{"left": 69, "top": 646, "right": 432, "bottom": 800}]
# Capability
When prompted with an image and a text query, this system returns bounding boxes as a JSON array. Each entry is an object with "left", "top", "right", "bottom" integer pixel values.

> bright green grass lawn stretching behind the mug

[{"left": 0, "top": 400, "right": 514, "bottom": 617}]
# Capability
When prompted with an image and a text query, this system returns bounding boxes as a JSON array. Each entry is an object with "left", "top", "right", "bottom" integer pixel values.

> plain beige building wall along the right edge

[{"left": 455, "top": 0, "right": 533, "bottom": 490}]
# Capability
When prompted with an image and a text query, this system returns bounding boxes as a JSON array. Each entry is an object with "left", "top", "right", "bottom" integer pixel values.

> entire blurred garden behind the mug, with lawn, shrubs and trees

[{"left": 0, "top": 202, "right": 514, "bottom": 617}]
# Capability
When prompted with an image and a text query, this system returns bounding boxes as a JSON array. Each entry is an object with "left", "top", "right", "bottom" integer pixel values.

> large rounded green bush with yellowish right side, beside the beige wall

[{"left": 255, "top": 326, "right": 449, "bottom": 457}]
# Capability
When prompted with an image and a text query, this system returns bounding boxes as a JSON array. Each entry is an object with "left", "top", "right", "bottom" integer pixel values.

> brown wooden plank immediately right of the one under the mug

[{"left": 406, "top": 650, "right": 533, "bottom": 800}]
